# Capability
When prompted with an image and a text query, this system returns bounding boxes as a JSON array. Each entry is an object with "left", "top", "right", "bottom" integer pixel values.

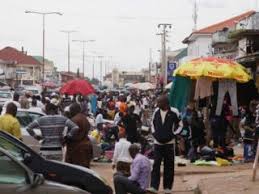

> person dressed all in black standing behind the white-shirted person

[{"left": 122, "top": 104, "right": 141, "bottom": 143}]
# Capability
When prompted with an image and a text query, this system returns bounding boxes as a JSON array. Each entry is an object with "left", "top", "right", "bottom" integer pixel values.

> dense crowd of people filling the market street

[{"left": 0, "top": 88, "right": 259, "bottom": 194}]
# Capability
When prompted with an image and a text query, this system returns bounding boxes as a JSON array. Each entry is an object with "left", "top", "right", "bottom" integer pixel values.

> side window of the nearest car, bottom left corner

[{"left": 0, "top": 151, "right": 27, "bottom": 185}]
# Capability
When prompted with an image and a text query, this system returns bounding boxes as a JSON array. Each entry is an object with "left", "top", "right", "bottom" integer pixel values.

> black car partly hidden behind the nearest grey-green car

[{"left": 0, "top": 131, "right": 112, "bottom": 194}]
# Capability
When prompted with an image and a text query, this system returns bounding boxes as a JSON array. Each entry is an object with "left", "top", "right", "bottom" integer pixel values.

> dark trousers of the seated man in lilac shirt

[{"left": 113, "top": 174, "right": 146, "bottom": 194}]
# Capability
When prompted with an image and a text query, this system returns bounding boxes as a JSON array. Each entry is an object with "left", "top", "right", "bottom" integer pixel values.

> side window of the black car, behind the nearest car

[{"left": 0, "top": 136, "right": 23, "bottom": 161}]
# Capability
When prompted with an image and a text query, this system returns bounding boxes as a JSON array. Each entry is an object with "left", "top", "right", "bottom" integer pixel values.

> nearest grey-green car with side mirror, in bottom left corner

[{"left": 0, "top": 147, "right": 90, "bottom": 194}]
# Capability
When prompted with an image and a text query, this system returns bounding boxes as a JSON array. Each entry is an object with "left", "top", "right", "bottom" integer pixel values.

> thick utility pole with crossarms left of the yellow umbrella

[{"left": 158, "top": 24, "right": 172, "bottom": 86}]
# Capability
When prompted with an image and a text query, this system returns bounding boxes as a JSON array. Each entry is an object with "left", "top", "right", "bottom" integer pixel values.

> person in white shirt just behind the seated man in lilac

[{"left": 112, "top": 127, "right": 132, "bottom": 169}]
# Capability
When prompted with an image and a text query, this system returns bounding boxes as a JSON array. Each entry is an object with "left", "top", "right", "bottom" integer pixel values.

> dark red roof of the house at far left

[{"left": 0, "top": 47, "right": 41, "bottom": 65}]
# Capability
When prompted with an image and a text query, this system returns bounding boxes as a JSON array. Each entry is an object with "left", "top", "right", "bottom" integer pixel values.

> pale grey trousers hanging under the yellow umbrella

[{"left": 216, "top": 80, "right": 238, "bottom": 116}]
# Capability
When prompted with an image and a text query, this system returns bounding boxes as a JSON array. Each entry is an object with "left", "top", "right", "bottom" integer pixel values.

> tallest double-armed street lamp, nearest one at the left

[{"left": 25, "top": 10, "right": 63, "bottom": 82}]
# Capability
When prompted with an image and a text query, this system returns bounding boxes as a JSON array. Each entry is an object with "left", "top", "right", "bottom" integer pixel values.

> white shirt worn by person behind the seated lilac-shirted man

[{"left": 112, "top": 138, "right": 132, "bottom": 164}]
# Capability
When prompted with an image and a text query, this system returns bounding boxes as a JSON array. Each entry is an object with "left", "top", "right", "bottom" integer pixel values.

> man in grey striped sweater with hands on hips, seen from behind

[{"left": 27, "top": 103, "right": 79, "bottom": 161}]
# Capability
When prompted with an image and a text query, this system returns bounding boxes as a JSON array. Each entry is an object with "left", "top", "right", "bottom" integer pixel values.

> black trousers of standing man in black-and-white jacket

[{"left": 151, "top": 144, "right": 174, "bottom": 190}]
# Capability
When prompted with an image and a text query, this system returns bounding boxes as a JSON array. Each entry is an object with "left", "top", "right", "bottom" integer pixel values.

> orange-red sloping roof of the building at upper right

[{"left": 183, "top": 10, "right": 256, "bottom": 43}]
